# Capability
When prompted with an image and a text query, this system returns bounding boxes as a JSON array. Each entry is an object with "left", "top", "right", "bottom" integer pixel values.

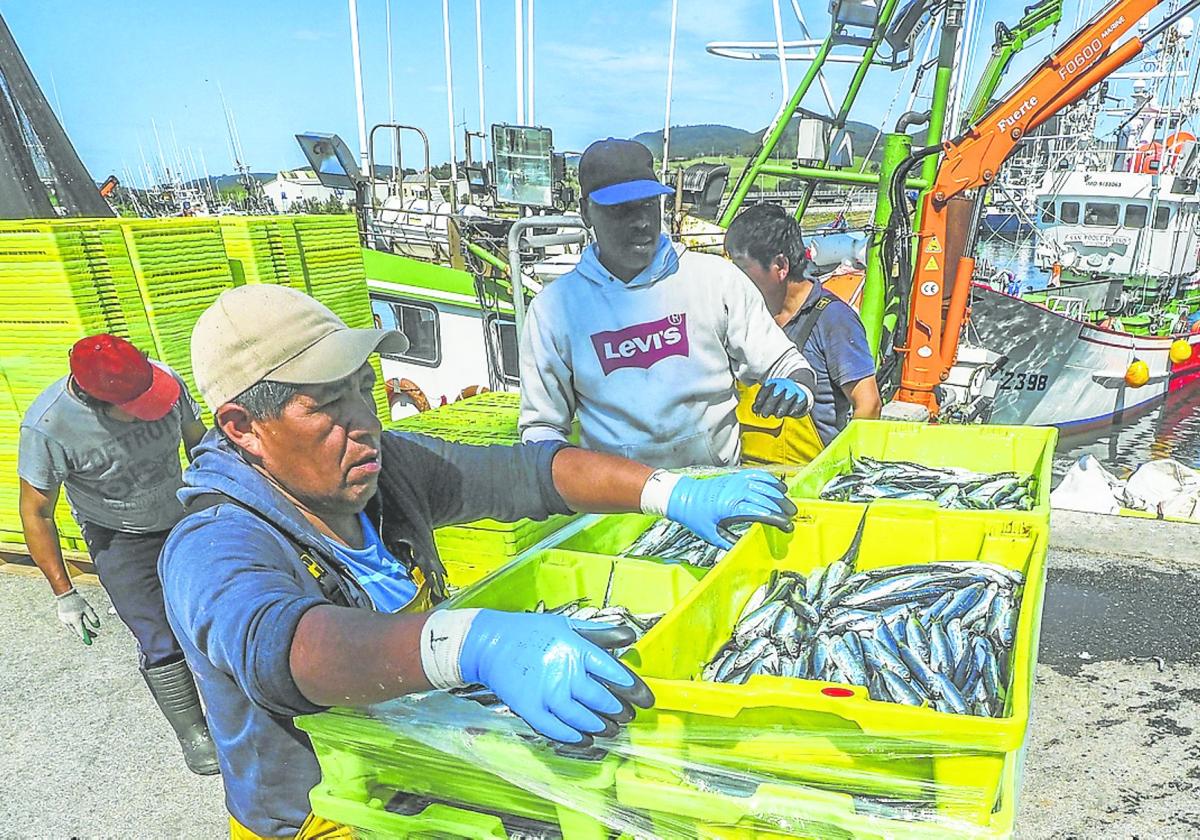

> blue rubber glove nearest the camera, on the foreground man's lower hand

[{"left": 458, "top": 610, "right": 654, "bottom": 746}]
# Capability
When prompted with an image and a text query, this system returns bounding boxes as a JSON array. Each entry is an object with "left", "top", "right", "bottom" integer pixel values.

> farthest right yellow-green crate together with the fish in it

[{"left": 788, "top": 420, "right": 1058, "bottom": 521}]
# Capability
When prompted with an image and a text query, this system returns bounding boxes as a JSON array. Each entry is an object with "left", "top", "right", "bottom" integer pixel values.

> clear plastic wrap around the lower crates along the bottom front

[{"left": 305, "top": 692, "right": 1021, "bottom": 840}]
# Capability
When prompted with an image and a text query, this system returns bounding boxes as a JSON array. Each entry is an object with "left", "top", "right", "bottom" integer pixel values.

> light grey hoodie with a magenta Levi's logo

[{"left": 521, "top": 235, "right": 809, "bottom": 468}]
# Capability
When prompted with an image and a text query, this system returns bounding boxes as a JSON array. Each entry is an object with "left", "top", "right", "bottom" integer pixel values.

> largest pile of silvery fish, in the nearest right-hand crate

[{"left": 702, "top": 520, "right": 1025, "bottom": 718}]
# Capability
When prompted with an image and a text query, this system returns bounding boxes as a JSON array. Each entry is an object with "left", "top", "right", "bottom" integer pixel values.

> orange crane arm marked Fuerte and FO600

[{"left": 896, "top": 0, "right": 1200, "bottom": 416}]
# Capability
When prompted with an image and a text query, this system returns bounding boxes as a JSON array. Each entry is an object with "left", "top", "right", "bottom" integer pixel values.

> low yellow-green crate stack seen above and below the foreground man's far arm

[{"left": 391, "top": 392, "right": 572, "bottom": 588}]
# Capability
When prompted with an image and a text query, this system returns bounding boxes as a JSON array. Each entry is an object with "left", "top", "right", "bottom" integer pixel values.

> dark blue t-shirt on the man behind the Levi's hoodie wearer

[{"left": 784, "top": 283, "right": 875, "bottom": 446}]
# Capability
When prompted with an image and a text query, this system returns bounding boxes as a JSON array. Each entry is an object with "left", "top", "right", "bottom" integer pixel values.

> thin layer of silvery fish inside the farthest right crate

[{"left": 821, "top": 456, "right": 1036, "bottom": 510}]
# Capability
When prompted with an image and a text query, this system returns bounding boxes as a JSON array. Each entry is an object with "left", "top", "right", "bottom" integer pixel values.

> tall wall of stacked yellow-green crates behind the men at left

[{"left": 0, "top": 216, "right": 388, "bottom": 550}]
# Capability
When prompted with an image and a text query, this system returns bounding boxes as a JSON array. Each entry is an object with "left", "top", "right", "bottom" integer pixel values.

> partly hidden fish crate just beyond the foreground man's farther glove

[{"left": 557, "top": 514, "right": 750, "bottom": 569}]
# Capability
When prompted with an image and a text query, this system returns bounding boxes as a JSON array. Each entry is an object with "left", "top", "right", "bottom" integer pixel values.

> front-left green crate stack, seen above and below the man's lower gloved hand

[{"left": 296, "top": 551, "right": 701, "bottom": 840}]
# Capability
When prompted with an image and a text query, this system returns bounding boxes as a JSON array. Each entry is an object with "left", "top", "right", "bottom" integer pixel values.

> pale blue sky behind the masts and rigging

[{"left": 0, "top": 0, "right": 1113, "bottom": 179}]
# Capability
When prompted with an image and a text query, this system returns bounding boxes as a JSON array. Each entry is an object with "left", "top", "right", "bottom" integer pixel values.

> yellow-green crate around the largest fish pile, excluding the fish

[{"left": 625, "top": 502, "right": 1048, "bottom": 822}]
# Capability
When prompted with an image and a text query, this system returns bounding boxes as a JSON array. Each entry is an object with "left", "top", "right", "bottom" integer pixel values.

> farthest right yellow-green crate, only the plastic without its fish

[{"left": 787, "top": 420, "right": 1058, "bottom": 523}]
